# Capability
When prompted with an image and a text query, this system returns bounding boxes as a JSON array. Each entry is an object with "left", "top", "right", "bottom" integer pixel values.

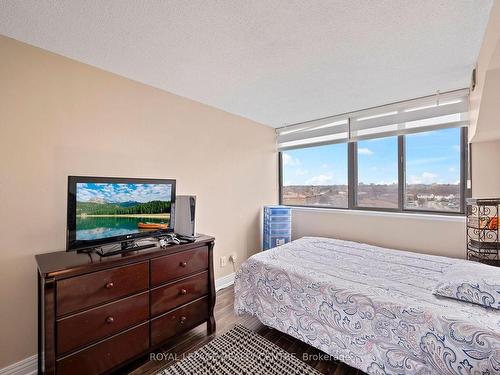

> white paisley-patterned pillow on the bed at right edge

[{"left": 433, "top": 262, "right": 500, "bottom": 310}]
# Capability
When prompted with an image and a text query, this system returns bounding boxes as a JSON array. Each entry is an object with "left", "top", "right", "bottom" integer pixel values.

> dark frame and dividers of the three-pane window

[{"left": 278, "top": 127, "right": 471, "bottom": 216}]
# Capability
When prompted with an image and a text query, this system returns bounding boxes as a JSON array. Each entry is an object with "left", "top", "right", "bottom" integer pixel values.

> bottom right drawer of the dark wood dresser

[{"left": 151, "top": 297, "right": 208, "bottom": 346}]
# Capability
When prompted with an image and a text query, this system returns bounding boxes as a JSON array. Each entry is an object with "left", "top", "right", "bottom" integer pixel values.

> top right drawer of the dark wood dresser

[{"left": 151, "top": 246, "right": 208, "bottom": 286}]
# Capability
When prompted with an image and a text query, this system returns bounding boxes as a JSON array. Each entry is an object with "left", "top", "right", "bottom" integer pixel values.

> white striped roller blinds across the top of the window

[{"left": 277, "top": 89, "right": 469, "bottom": 151}]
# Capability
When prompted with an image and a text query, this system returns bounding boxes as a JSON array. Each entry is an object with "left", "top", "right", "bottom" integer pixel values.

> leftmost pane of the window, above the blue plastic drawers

[{"left": 281, "top": 143, "right": 348, "bottom": 208}]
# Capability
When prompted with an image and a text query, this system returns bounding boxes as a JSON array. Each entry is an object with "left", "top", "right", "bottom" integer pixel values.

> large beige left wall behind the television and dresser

[{"left": 0, "top": 36, "right": 277, "bottom": 368}]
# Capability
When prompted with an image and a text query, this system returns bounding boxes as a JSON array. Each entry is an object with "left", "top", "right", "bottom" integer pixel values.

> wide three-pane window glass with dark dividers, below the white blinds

[{"left": 281, "top": 128, "right": 467, "bottom": 213}]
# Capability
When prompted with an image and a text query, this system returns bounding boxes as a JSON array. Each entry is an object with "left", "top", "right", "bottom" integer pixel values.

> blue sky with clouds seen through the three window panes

[{"left": 283, "top": 128, "right": 460, "bottom": 186}]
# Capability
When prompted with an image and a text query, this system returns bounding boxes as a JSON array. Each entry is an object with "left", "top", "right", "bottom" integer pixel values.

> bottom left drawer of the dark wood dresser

[{"left": 56, "top": 323, "right": 149, "bottom": 375}]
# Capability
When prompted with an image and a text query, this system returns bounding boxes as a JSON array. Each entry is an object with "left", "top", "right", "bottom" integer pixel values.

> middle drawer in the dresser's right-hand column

[{"left": 151, "top": 271, "right": 208, "bottom": 316}]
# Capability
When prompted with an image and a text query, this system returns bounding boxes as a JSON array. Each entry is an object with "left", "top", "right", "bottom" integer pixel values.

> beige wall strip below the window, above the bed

[{"left": 292, "top": 208, "right": 465, "bottom": 258}]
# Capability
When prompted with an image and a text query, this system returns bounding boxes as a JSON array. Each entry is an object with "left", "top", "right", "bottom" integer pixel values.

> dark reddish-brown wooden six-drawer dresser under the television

[{"left": 36, "top": 235, "right": 215, "bottom": 375}]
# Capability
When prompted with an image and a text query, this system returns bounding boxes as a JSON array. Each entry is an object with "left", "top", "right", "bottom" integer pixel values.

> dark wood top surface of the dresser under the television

[{"left": 35, "top": 234, "right": 215, "bottom": 279}]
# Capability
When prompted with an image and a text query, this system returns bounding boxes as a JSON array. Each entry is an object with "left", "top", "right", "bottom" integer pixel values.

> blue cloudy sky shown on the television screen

[{"left": 76, "top": 183, "right": 172, "bottom": 203}]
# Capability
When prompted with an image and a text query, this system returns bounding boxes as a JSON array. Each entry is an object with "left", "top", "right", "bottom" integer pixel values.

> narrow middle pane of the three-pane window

[{"left": 356, "top": 137, "right": 399, "bottom": 209}]
